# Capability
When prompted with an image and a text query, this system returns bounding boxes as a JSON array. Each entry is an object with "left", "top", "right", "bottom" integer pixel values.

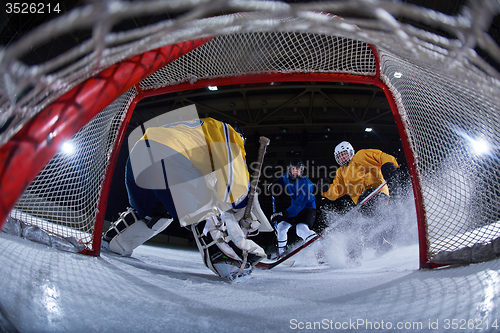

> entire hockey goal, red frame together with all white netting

[{"left": 0, "top": 0, "right": 500, "bottom": 267}]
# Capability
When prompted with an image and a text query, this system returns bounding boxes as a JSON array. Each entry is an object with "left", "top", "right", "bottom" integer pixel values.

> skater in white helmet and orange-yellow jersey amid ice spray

[{"left": 318, "top": 141, "right": 400, "bottom": 261}]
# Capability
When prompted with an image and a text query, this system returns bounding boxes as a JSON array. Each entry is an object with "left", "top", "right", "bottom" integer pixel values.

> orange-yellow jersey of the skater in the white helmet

[{"left": 322, "top": 149, "right": 399, "bottom": 204}]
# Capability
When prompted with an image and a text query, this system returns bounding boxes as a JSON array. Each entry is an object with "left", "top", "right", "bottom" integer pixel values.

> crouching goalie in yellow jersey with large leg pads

[{"left": 102, "top": 106, "right": 273, "bottom": 280}]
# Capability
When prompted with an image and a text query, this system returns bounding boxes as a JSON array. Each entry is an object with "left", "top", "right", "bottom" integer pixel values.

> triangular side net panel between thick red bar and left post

[{"left": 10, "top": 89, "right": 137, "bottom": 247}]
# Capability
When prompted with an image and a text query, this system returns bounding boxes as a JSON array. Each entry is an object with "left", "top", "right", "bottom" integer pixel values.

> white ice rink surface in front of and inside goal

[{"left": 0, "top": 228, "right": 500, "bottom": 332}]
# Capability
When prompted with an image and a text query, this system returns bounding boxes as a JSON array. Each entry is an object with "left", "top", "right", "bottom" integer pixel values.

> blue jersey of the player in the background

[{"left": 273, "top": 173, "right": 316, "bottom": 217}]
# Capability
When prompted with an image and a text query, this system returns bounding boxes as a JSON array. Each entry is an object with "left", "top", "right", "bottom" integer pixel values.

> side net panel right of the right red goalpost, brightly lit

[{"left": 380, "top": 51, "right": 500, "bottom": 256}]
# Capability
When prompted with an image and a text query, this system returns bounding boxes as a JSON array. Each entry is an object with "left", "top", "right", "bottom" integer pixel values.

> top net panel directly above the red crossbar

[{"left": 139, "top": 32, "right": 376, "bottom": 90}]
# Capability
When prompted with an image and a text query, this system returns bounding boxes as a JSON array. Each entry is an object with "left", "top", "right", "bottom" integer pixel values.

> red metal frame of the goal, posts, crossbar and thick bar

[{"left": 0, "top": 38, "right": 433, "bottom": 268}]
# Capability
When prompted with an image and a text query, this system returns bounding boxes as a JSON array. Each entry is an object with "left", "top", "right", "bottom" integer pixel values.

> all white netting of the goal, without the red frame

[{"left": 0, "top": 1, "right": 500, "bottom": 257}]
